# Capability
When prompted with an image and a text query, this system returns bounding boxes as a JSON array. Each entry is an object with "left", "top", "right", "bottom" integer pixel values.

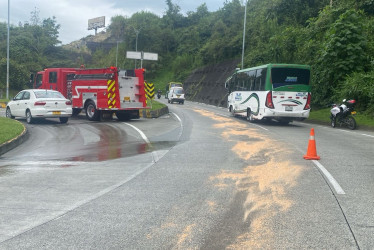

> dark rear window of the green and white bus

[{"left": 271, "top": 68, "right": 310, "bottom": 88}]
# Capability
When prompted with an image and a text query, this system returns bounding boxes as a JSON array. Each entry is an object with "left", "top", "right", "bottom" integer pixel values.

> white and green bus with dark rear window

[{"left": 225, "top": 64, "right": 311, "bottom": 124}]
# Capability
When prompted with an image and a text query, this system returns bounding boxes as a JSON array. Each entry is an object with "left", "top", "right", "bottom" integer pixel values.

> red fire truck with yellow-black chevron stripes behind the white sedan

[{"left": 31, "top": 67, "right": 147, "bottom": 121}]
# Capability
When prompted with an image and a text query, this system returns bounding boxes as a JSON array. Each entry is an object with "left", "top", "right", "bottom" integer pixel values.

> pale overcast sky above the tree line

[{"left": 0, "top": 0, "right": 225, "bottom": 44}]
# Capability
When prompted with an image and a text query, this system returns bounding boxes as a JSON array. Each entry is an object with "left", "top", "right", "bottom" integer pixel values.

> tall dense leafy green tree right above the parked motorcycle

[{"left": 319, "top": 9, "right": 369, "bottom": 103}]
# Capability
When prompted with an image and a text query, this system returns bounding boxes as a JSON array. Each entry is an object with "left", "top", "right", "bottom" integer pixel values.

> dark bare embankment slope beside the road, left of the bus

[{"left": 183, "top": 60, "right": 239, "bottom": 107}]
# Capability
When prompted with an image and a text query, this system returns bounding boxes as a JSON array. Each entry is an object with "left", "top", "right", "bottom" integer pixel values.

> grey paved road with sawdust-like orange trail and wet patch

[{"left": 0, "top": 100, "right": 374, "bottom": 249}]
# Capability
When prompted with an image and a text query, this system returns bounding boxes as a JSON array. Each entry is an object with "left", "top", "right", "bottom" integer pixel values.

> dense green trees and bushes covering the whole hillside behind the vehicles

[{"left": 0, "top": 0, "right": 374, "bottom": 116}]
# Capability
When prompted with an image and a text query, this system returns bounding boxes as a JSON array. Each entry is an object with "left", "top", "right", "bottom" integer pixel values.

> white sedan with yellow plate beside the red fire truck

[{"left": 6, "top": 89, "right": 72, "bottom": 123}]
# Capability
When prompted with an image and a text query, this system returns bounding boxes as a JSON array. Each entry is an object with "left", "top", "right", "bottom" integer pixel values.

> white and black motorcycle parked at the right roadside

[{"left": 330, "top": 99, "right": 357, "bottom": 130}]
